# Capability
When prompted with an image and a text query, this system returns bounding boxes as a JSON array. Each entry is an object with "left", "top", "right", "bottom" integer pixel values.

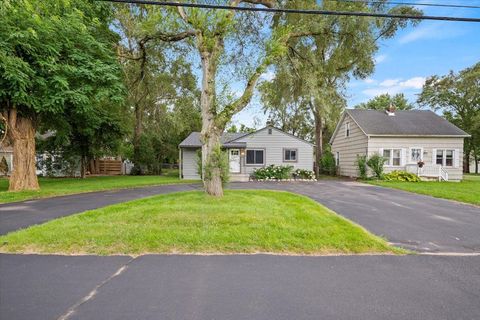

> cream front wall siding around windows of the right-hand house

[{"left": 368, "top": 137, "right": 463, "bottom": 180}]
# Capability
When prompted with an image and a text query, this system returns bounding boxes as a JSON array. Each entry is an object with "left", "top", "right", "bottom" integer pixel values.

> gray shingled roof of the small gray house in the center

[{"left": 179, "top": 126, "right": 314, "bottom": 148}]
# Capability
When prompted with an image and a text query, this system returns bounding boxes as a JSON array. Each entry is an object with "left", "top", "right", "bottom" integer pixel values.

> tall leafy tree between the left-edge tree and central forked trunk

[{"left": 115, "top": 4, "right": 201, "bottom": 174}]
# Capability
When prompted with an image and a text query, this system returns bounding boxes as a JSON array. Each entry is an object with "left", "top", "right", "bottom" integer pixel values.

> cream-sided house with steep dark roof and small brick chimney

[{"left": 330, "top": 108, "right": 469, "bottom": 181}]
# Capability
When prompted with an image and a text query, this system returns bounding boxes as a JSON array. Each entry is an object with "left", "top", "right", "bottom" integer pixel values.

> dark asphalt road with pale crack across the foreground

[{"left": 0, "top": 255, "right": 480, "bottom": 320}]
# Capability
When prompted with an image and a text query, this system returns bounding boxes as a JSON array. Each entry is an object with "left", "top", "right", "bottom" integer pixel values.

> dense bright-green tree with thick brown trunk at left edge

[{"left": 0, "top": 0, "right": 123, "bottom": 191}]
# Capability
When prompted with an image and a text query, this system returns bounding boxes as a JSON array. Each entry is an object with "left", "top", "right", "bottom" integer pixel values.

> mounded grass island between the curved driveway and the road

[{"left": 0, "top": 190, "right": 405, "bottom": 255}]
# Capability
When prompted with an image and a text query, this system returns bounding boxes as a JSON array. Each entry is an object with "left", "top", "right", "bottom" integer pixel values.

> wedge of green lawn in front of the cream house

[{"left": 369, "top": 175, "right": 480, "bottom": 205}]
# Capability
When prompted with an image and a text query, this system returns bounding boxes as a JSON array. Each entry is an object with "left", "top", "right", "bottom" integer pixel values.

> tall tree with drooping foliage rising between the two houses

[{"left": 263, "top": 0, "right": 421, "bottom": 175}]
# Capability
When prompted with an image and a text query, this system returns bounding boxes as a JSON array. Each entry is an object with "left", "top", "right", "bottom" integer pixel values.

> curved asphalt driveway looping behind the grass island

[{"left": 0, "top": 180, "right": 480, "bottom": 253}]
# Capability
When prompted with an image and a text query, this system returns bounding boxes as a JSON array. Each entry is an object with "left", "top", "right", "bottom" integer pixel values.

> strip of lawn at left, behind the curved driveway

[{"left": 0, "top": 170, "right": 197, "bottom": 203}]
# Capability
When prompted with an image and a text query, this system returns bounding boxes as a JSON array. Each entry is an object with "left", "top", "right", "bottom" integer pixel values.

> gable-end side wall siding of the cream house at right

[{"left": 332, "top": 114, "right": 368, "bottom": 177}]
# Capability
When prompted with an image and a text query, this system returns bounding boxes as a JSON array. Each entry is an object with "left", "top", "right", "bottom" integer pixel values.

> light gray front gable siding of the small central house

[{"left": 236, "top": 128, "right": 313, "bottom": 174}]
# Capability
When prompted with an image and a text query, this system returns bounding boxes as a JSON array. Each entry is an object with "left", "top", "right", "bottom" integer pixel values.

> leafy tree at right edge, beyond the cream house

[{"left": 418, "top": 63, "right": 480, "bottom": 173}]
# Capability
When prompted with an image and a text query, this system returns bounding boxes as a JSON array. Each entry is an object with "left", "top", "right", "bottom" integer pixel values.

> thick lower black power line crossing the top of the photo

[{"left": 96, "top": 0, "right": 480, "bottom": 22}]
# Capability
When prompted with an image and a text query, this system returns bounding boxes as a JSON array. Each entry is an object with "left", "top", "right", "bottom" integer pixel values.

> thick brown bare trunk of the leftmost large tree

[{"left": 7, "top": 109, "right": 40, "bottom": 191}]
